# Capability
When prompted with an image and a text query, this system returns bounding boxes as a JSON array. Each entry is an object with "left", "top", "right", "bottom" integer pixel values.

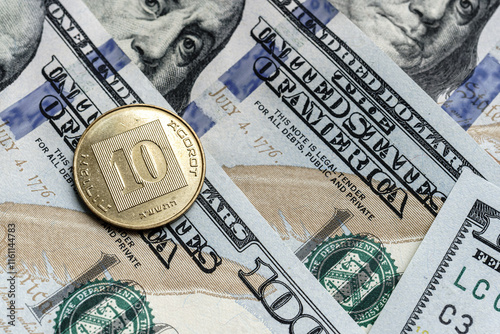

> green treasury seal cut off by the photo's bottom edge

[{"left": 54, "top": 280, "right": 154, "bottom": 334}]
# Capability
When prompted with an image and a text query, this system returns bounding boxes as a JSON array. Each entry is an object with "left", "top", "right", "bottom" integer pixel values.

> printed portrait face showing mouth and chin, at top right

[{"left": 332, "top": 0, "right": 499, "bottom": 73}]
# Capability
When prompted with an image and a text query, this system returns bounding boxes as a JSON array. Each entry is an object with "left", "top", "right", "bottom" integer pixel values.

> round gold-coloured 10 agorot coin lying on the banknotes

[{"left": 73, "top": 105, "right": 205, "bottom": 229}]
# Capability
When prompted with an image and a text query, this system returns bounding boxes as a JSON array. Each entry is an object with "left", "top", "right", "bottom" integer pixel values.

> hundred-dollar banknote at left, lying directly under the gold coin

[{"left": 0, "top": 0, "right": 362, "bottom": 334}]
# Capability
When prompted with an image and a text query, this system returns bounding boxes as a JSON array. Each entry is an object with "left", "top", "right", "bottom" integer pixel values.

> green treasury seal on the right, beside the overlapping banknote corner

[{"left": 306, "top": 235, "right": 399, "bottom": 327}]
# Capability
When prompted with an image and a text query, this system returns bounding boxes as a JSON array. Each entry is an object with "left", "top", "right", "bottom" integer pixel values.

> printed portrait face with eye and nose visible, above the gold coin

[{"left": 86, "top": 0, "right": 244, "bottom": 102}]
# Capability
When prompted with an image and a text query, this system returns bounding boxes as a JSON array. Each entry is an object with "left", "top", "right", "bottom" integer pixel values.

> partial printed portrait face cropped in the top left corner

[{"left": 0, "top": 0, "right": 45, "bottom": 90}]
